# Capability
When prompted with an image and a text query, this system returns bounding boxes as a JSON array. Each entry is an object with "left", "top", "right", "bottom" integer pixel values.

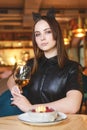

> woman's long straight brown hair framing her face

[{"left": 32, "top": 12, "right": 68, "bottom": 71}]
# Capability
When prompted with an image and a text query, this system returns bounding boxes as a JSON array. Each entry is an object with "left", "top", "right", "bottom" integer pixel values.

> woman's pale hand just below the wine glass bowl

[{"left": 11, "top": 85, "right": 31, "bottom": 112}]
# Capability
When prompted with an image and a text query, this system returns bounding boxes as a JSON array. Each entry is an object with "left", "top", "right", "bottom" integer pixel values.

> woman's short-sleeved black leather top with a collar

[{"left": 25, "top": 57, "right": 82, "bottom": 104}]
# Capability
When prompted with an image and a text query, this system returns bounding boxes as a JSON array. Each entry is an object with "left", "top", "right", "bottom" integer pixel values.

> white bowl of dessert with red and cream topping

[{"left": 28, "top": 106, "right": 58, "bottom": 122}]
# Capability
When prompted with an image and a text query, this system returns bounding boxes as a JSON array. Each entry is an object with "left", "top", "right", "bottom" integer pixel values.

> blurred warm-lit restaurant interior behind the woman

[{"left": 0, "top": 0, "right": 87, "bottom": 112}]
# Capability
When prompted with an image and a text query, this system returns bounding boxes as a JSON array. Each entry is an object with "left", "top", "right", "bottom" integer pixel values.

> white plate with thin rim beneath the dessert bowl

[{"left": 18, "top": 112, "right": 67, "bottom": 126}]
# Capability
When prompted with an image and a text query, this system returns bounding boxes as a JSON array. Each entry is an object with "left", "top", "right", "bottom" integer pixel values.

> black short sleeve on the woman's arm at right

[{"left": 66, "top": 63, "right": 83, "bottom": 93}]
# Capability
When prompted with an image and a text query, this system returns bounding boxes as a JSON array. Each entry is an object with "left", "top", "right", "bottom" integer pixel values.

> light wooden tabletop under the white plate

[{"left": 0, "top": 114, "right": 87, "bottom": 130}]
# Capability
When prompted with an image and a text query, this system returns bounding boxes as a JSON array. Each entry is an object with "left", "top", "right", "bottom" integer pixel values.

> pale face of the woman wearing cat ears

[{"left": 35, "top": 20, "right": 56, "bottom": 56}]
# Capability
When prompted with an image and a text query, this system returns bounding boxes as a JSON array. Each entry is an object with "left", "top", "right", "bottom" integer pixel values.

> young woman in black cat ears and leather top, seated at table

[{"left": 0, "top": 8, "right": 82, "bottom": 116}]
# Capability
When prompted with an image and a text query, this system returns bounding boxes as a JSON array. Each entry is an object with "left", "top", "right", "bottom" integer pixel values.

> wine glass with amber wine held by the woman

[{"left": 13, "top": 63, "right": 31, "bottom": 92}]
